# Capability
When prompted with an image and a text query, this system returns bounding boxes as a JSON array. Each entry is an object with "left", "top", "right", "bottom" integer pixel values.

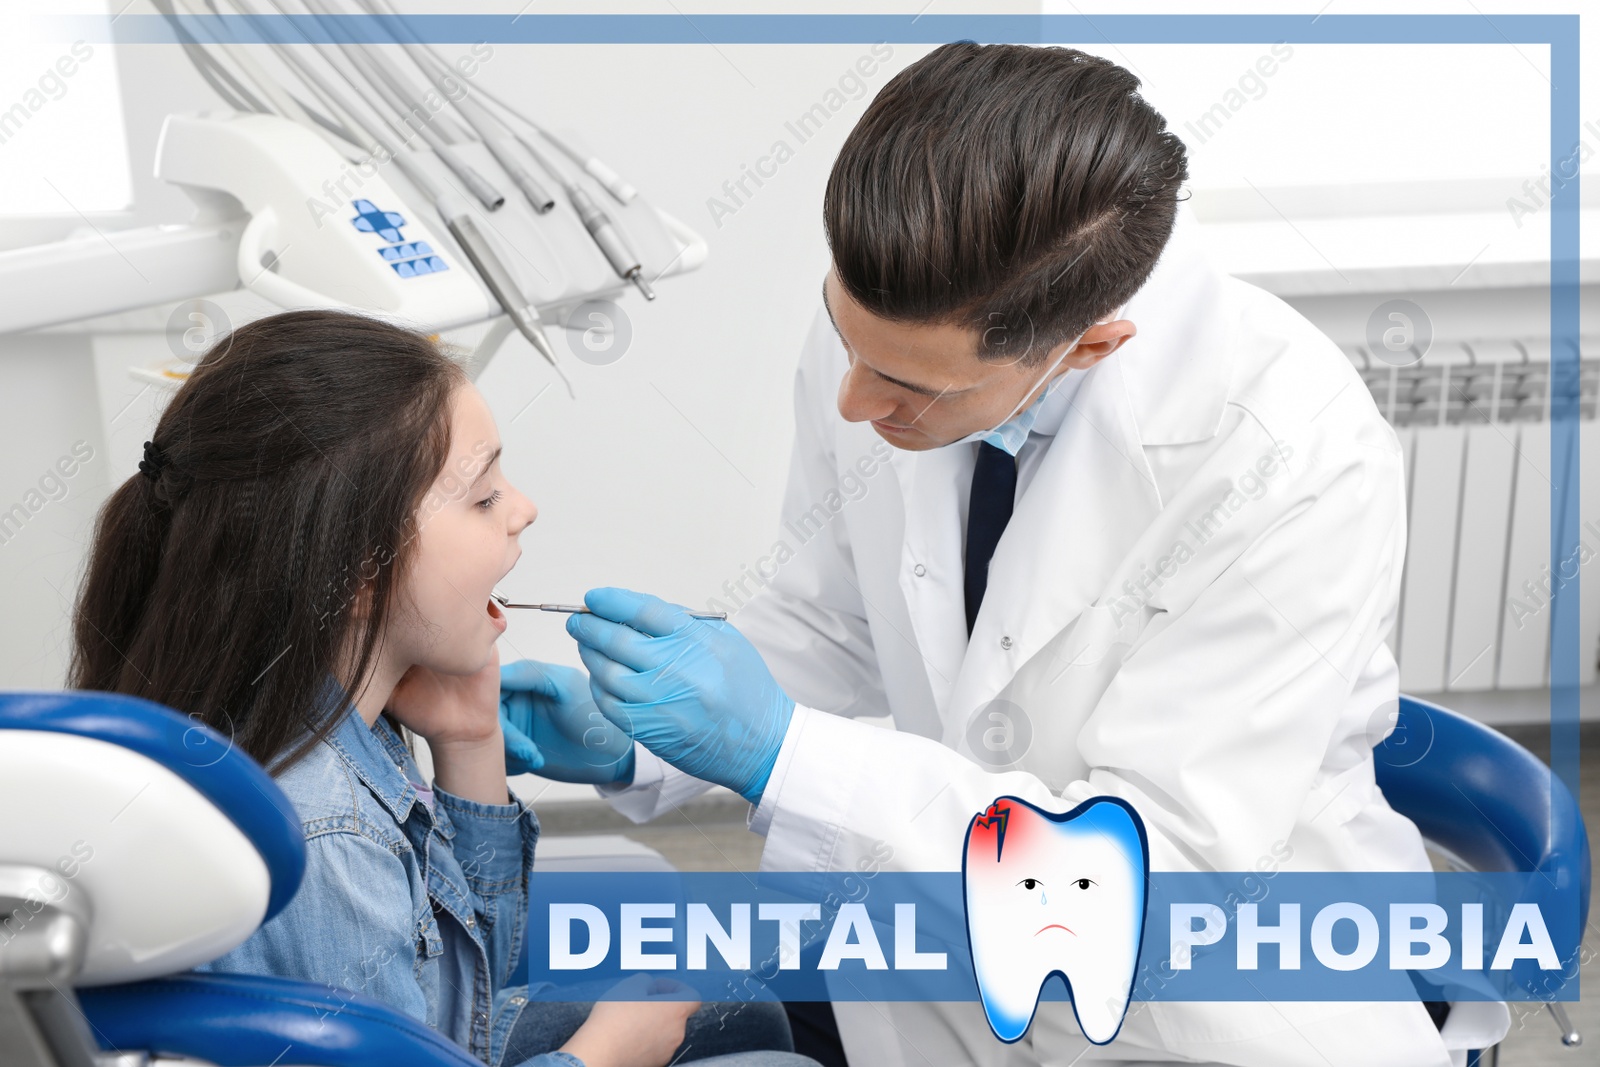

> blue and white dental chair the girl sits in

[{"left": 0, "top": 693, "right": 482, "bottom": 1067}]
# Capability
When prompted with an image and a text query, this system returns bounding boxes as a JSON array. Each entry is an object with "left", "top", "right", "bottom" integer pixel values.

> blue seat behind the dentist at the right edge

[{"left": 1373, "top": 696, "right": 1590, "bottom": 1062}]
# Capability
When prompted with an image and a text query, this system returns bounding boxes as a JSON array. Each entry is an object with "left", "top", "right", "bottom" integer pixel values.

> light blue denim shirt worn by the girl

[{"left": 197, "top": 707, "right": 582, "bottom": 1067}]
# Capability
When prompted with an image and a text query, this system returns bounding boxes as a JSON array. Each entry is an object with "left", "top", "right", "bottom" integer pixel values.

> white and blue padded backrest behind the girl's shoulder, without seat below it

[{"left": 0, "top": 691, "right": 306, "bottom": 985}]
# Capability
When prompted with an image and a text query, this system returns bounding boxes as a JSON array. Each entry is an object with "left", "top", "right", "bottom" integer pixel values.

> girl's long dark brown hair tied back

[{"left": 69, "top": 310, "right": 466, "bottom": 773}]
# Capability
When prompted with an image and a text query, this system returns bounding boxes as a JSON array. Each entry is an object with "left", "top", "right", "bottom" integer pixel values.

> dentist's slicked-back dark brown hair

[{"left": 822, "top": 42, "right": 1189, "bottom": 365}]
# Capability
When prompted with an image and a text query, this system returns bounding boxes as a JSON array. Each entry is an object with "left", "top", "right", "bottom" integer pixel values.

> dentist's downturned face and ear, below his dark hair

[{"left": 822, "top": 270, "right": 1134, "bottom": 451}]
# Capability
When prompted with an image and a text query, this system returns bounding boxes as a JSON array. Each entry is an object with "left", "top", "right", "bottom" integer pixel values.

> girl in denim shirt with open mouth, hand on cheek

[{"left": 70, "top": 312, "right": 811, "bottom": 1067}]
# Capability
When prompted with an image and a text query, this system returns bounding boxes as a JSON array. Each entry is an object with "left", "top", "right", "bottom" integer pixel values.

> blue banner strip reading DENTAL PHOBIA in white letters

[{"left": 528, "top": 872, "right": 1582, "bottom": 1001}]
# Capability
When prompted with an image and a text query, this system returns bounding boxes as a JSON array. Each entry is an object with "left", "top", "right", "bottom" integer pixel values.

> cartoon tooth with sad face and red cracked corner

[{"left": 962, "top": 797, "right": 1150, "bottom": 1045}]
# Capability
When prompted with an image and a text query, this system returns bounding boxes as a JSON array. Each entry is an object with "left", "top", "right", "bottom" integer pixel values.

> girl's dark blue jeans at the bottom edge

[{"left": 501, "top": 989, "right": 816, "bottom": 1067}]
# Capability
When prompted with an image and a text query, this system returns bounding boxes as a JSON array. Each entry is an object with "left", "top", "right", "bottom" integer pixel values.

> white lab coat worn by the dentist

[{"left": 603, "top": 218, "right": 1509, "bottom": 1067}]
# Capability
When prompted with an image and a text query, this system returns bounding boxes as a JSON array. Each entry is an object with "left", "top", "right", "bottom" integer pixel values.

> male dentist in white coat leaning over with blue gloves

[{"left": 502, "top": 43, "right": 1509, "bottom": 1067}]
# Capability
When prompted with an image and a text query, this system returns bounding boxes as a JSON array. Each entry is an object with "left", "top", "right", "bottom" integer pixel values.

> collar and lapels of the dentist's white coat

[{"left": 893, "top": 211, "right": 1232, "bottom": 725}]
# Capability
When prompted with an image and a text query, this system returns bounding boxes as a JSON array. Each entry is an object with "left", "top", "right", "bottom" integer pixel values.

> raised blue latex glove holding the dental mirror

[{"left": 566, "top": 589, "right": 795, "bottom": 805}]
